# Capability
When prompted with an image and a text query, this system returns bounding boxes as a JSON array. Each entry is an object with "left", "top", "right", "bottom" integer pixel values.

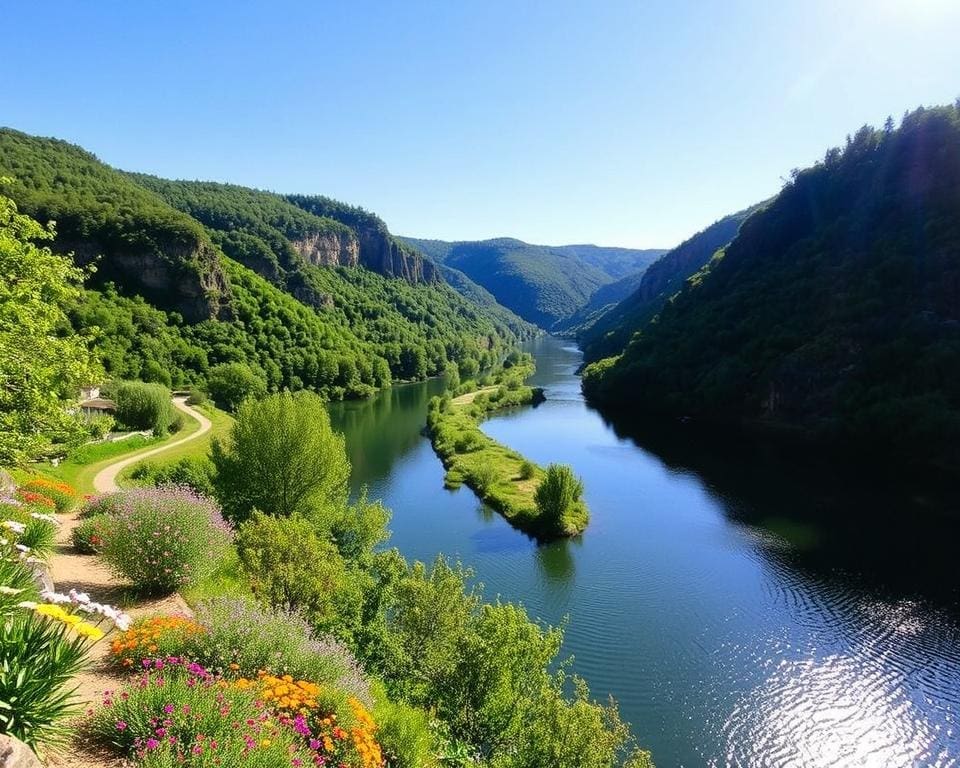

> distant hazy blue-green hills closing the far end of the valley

[{"left": 402, "top": 237, "right": 664, "bottom": 330}]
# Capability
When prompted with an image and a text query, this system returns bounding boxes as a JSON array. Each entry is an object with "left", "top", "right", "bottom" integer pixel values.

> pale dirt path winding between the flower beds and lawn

[{"left": 46, "top": 398, "right": 212, "bottom": 768}]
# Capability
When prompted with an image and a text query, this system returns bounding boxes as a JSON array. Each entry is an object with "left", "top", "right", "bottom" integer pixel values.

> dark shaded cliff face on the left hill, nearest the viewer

[{"left": 62, "top": 238, "right": 230, "bottom": 323}]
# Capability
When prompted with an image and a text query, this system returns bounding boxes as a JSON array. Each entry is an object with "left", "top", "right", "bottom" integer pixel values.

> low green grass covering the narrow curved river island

[{"left": 427, "top": 367, "right": 588, "bottom": 539}]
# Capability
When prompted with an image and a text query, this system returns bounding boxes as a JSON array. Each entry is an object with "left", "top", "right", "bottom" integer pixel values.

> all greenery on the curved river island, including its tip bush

[{"left": 427, "top": 352, "right": 589, "bottom": 539}]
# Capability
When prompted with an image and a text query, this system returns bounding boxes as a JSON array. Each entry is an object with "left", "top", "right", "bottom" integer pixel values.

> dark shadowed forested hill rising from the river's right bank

[{"left": 584, "top": 104, "right": 960, "bottom": 469}]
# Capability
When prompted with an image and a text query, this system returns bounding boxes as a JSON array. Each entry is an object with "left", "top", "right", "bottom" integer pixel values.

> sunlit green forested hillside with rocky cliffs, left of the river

[{"left": 0, "top": 129, "right": 535, "bottom": 398}]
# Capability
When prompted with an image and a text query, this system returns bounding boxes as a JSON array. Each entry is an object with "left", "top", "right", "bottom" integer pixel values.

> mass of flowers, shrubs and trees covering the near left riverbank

[{"left": 0, "top": 190, "right": 650, "bottom": 768}]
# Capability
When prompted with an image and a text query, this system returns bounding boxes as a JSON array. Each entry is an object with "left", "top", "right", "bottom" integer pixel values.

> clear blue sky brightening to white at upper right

[{"left": 0, "top": 0, "right": 960, "bottom": 247}]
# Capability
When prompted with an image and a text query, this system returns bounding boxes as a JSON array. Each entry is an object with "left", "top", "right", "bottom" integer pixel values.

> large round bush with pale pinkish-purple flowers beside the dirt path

[{"left": 101, "top": 486, "right": 230, "bottom": 594}]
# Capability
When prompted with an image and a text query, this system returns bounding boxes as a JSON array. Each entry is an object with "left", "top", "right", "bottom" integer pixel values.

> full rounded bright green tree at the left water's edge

[{"left": 212, "top": 392, "right": 350, "bottom": 522}]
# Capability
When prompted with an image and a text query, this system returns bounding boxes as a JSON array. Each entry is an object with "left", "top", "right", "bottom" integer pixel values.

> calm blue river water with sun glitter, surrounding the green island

[{"left": 332, "top": 338, "right": 960, "bottom": 768}]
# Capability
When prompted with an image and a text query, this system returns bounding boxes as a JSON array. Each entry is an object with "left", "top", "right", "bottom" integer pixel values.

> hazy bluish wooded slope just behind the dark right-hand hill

[{"left": 580, "top": 204, "right": 763, "bottom": 361}]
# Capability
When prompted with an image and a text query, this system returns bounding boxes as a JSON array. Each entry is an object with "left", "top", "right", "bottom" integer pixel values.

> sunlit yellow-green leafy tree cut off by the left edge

[{"left": 0, "top": 188, "right": 102, "bottom": 465}]
